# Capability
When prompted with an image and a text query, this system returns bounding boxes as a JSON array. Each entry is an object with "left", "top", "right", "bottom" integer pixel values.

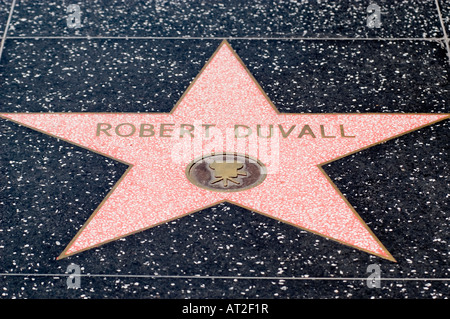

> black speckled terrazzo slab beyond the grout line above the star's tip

[{"left": 7, "top": 0, "right": 442, "bottom": 38}]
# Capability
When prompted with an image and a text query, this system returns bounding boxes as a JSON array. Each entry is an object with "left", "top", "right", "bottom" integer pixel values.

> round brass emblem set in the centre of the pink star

[{"left": 186, "top": 153, "right": 267, "bottom": 192}]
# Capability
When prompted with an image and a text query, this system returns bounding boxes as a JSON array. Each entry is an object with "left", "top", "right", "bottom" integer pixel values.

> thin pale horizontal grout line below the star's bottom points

[{"left": 0, "top": 273, "right": 450, "bottom": 281}]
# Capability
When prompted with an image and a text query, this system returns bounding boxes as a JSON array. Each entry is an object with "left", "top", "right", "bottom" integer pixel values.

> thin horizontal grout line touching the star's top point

[{"left": 3, "top": 35, "right": 446, "bottom": 42}]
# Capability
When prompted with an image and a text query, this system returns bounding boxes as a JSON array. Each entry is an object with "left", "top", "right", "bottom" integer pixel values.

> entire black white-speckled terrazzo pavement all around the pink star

[{"left": 0, "top": 0, "right": 450, "bottom": 299}]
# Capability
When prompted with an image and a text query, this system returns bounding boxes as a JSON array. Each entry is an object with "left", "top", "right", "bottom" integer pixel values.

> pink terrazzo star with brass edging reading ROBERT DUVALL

[{"left": 0, "top": 41, "right": 449, "bottom": 261}]
